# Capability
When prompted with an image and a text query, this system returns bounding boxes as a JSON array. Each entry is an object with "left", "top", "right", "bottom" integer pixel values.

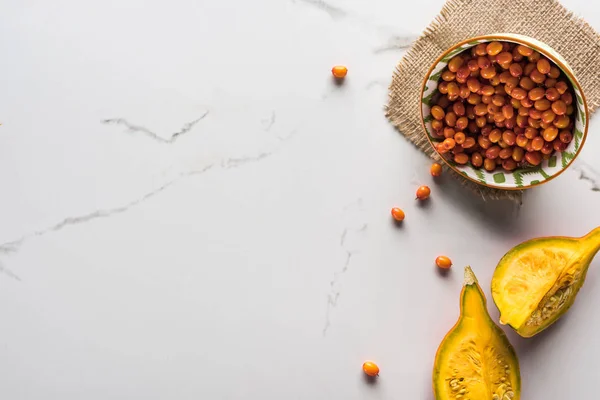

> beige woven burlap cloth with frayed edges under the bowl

[{"left": 386, "top": 0, "right": 600, "bottom": 203}]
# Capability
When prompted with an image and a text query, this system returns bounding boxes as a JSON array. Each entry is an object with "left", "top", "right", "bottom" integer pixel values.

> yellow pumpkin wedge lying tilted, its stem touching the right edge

[{"left": 492, "top": 227, "right": 600, "bottom": 337}]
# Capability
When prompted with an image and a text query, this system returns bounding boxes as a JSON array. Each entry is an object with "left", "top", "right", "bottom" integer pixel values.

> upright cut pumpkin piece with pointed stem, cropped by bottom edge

[{"left": 433, "top": 267, "right": 521, "bottom": 400}]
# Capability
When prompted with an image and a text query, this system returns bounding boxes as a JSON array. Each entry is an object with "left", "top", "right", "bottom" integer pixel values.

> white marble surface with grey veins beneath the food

[{"left": 0, "top": 0, "right": 600, "bottom": 400}]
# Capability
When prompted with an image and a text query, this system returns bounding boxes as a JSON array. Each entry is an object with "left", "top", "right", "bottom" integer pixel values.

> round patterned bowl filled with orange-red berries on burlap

[{"left": 421, "top": 35, "right": 588, "bottom": 189}]
